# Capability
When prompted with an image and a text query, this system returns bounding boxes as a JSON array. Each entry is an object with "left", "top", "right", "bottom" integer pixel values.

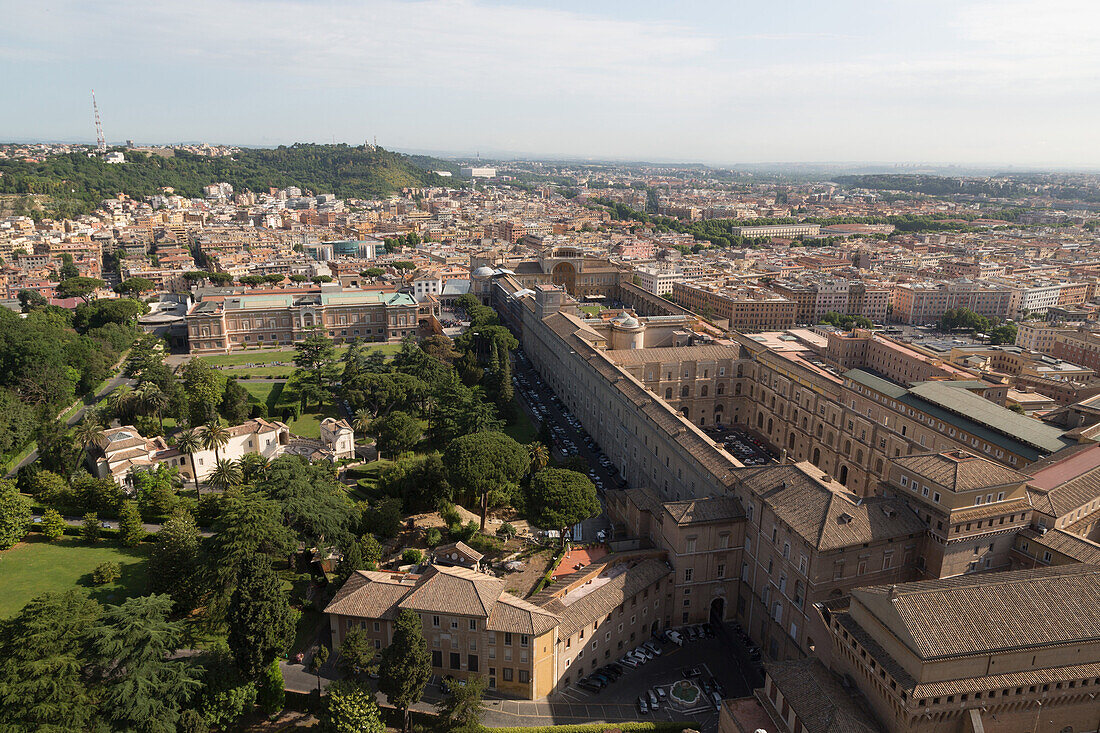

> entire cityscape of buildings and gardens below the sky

[{"left": 0, "top": 138, "right": 1100, "bottom": 733}]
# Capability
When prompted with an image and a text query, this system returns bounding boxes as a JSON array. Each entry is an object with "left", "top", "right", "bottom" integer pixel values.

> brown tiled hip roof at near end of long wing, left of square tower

[{"left": 738, "top": 462, "right": 925, "bottom": 550}]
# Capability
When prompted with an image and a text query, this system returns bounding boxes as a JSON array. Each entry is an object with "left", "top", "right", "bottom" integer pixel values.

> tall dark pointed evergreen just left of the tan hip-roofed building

[{"left": 228, "top": 555, "right": 294, "bottom": 678}]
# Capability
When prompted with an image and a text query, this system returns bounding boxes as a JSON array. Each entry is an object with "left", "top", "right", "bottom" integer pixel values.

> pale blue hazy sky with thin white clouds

[{"left": 0, "top": 0, "right": 1100, "bottom": 167}]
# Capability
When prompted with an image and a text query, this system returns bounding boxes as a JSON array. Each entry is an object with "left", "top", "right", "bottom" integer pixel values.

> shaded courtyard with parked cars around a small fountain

[{"left": 483, "top": 620, "right": 750, "bottom": 733}]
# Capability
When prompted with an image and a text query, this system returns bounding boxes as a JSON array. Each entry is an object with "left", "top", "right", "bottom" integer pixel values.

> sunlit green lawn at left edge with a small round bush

[{"left": 0, "top": 534, "right": 149, "bottom": 619}]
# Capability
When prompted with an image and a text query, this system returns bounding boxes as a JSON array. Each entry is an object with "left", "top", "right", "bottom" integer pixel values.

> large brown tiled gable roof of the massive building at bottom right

[{"left": 851, "top": 565, "right": 1100, "bottom": 659}]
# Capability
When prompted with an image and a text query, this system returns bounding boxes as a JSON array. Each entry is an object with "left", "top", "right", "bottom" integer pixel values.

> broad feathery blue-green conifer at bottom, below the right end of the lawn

[{"left": 87, "top": 595, "right": 199, "bottom": 733}]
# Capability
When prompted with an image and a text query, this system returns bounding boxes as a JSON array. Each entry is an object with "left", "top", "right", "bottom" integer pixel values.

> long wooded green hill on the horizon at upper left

[{"left": 0, "top": 143, "right": 453, "bottom": 216}]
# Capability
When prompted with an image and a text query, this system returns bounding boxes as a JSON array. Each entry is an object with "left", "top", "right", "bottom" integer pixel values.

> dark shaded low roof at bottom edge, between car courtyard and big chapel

[{"left": 768, "top": 658, "right": 882, "bottom": 733}]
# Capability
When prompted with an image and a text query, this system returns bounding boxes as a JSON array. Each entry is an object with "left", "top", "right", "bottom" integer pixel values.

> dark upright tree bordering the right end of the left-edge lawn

[{"left": 149, "top": 508, "right": 201, "bottom": 613}]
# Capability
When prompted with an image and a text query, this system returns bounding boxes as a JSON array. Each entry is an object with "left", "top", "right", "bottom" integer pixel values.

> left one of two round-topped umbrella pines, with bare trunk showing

[{"left": 443, "top": 433, "right": 529, "bottom": 532}]
